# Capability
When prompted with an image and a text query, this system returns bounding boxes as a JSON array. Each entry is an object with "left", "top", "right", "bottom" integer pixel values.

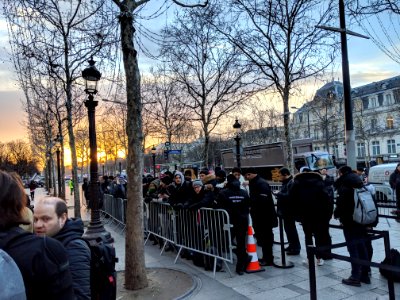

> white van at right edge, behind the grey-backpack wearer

[{"left": 368, "top": 163, "right": 397, "bottom": 202}]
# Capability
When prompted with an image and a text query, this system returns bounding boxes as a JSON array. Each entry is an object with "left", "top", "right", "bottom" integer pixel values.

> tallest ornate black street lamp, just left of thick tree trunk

[{"left": 82, "top": 58, "right": 114, "bottom": 246}]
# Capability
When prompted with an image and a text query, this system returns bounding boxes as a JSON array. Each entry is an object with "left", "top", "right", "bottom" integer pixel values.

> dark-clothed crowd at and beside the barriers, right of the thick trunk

[{"left": 143, "top": 166, "right": 382, "bottom": 286}]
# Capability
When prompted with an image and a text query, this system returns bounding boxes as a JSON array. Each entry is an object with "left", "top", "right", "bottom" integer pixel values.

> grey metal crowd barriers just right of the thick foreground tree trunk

[{"left": 145, "top": 201, "right": 233, "bottom": 277}]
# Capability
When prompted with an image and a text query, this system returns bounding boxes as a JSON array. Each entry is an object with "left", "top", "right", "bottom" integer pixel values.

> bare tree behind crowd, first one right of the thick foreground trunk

[{"left": 161, "top": 5, "right": 251, "bottom": 164}]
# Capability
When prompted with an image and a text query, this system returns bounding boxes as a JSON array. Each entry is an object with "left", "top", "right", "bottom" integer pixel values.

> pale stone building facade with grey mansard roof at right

[{"left": 291, "top": 76, "right": 400, "bottom": 166}]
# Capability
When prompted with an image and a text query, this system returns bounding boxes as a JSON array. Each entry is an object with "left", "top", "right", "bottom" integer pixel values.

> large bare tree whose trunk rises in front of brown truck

[{"left": 219, "top": 0, "right": 335, "bottom": 169}]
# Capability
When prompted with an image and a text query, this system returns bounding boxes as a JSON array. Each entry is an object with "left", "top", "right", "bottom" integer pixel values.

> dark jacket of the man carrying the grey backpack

[{"left": 334, "top": 173, "right": 363, "bottom": 226}]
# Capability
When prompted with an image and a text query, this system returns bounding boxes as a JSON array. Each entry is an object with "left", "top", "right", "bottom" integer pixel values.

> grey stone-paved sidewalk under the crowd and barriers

[{"left": 32, "top": 191, "right": 400, "bottom": 300}]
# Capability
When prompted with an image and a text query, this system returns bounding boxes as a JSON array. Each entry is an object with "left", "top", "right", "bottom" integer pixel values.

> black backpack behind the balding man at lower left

[{"left": 86, "top": 237, "right": 118, "bottom": 300}]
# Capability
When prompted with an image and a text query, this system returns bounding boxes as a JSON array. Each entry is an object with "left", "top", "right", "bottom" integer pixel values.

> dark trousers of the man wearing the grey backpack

[{"left": 343, "top": 225, "right": 370, "bottom": 280}]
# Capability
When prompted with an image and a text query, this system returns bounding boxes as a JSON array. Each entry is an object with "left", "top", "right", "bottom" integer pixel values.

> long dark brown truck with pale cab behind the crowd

[{"left": 221, "top": 139, "right": 336, "bottom": 182}]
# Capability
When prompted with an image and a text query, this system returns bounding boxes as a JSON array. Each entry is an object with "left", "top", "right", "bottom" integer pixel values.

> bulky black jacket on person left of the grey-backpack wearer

[{"left": 289, "top": 172, "right": 333, "bottom": 222}]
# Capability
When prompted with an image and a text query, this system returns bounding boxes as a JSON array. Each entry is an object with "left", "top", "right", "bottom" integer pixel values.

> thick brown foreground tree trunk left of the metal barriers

[{"left": 120, "top": 6, "right": 148, "bottom": 290}]
